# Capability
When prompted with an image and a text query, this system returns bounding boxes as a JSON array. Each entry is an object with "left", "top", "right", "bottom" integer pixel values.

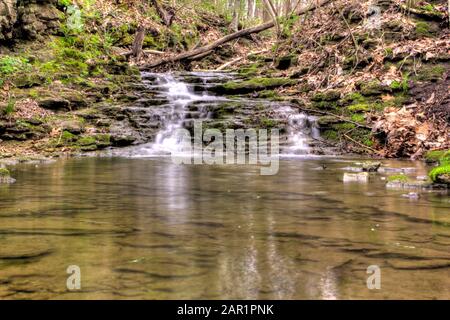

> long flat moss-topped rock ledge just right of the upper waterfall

[{"left": 211, "top": 78, "right": 297, "bottom": 94}]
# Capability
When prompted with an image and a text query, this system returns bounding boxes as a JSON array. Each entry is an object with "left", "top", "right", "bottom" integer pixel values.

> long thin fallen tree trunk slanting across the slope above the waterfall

[{"left": 139, "top": 0, "right": 331, "bottom": 70}]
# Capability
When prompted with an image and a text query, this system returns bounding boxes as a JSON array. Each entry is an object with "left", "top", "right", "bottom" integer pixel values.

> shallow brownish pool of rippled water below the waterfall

[{"left": 0, "top": 158, "right": 450, "bottom": 299}]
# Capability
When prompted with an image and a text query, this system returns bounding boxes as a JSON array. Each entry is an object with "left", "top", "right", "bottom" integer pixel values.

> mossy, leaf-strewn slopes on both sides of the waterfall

[{"left": 0, "top": 0, "right": 450, "bottom": 165}]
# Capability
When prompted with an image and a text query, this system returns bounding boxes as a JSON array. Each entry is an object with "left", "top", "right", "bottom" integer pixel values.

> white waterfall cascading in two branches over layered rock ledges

[{"left": 126, "top": 72, "right": 320, "bottom": 157}]
